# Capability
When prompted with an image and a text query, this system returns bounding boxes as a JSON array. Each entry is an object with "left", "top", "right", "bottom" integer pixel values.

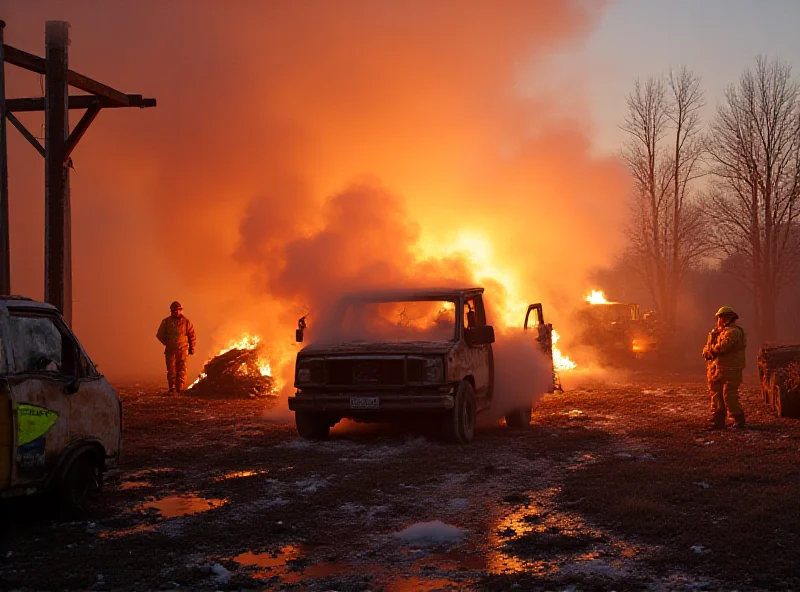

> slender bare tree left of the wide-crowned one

[{"left": 622, "top": 67, "right": 707, "bottom": 324}]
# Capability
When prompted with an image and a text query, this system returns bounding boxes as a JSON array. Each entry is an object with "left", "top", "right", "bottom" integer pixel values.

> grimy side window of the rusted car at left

[{"left": 9, "top": 314, "right": 76, "bottom": 376}]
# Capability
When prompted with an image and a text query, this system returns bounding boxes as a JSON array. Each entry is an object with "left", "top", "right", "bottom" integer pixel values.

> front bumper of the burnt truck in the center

[{"left": 289, "top": 392, "right": 455, "bottom": 417}]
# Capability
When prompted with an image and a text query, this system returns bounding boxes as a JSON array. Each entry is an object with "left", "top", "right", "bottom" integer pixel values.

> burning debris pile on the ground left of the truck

[{"left": 188, "top": 335, "right": 277, "bottom": 398}]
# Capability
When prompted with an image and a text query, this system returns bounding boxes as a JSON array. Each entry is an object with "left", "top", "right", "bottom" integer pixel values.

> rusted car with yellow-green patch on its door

[{"left": 0, "top": 296, "right": 122, "bottom": 513}]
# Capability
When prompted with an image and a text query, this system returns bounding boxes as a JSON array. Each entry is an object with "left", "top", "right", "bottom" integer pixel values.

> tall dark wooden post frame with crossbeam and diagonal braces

[{"left": 0, "top": 21, "right": 156, "bottom": 325}]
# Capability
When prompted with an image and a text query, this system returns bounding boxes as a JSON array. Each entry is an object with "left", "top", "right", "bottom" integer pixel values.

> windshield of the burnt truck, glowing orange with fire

[{"left": 331, "top": 300, "right": 456, "bottom": 343}]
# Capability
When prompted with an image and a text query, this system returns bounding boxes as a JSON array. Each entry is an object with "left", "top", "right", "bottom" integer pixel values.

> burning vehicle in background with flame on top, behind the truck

[{"left": 575, "top": 290, "right": 660, "bottom": 365}]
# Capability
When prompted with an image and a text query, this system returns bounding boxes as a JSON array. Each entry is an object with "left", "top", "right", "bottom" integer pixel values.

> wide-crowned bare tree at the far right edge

[{"left": 707, "top": 57, "right": 800, "bottom": 341}]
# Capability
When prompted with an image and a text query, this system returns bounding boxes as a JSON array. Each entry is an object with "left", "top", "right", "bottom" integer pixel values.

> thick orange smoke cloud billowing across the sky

[{"left": 2, "top": 0, "right": 627, "bottom": 379}]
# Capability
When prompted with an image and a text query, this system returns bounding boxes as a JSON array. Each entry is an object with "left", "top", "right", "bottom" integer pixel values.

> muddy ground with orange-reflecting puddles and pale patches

[{"left": 0, "top": 376, "right": 800, "bottom": 591}]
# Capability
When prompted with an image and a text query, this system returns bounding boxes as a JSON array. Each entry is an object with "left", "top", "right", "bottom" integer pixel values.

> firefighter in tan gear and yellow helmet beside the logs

[{"left": 703, "top": 306, "right": 747, "bottom": 429}]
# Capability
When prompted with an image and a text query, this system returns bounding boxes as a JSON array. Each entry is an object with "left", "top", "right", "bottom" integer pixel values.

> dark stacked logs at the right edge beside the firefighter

[{"left": 758, "top": 345, "right": 800, "bottom": 417}]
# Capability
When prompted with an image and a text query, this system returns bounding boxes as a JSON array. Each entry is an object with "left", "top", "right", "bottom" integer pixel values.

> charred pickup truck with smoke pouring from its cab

[{"left": 289, "top": 288, "right": 555, "bottom": 444}]
